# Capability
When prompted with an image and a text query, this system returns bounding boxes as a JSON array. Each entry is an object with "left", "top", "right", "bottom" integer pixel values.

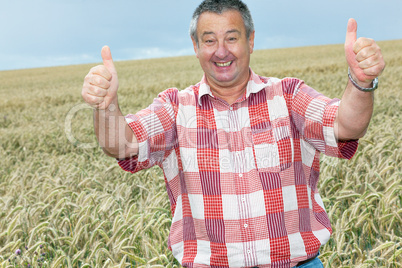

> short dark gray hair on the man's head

[{"left": 190, "top": 0, "right": 254, "bottom": 46}]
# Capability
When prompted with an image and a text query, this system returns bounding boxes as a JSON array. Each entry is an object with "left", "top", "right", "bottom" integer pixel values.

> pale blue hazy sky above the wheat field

[{"left": 0, "top": 0, "right": 402, "bottom": 71}]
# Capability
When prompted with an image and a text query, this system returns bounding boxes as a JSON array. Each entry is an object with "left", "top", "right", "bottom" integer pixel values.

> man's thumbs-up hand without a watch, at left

[{"left": 81, "top": 46, "right": 119, "bottom": 110}]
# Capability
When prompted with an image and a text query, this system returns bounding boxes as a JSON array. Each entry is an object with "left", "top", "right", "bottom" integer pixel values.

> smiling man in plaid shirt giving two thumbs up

[{"left": 82, "top": 0, "right": 385, "bottom": 267}]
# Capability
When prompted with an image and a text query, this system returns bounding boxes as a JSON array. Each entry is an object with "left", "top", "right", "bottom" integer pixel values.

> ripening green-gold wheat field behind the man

[{"left": 0, "top": 40, "right": 402, "bottom": 268}]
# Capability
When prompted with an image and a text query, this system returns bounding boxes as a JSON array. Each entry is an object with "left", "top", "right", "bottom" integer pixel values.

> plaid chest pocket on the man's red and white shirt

[{"left": 251, "top": 118, "right": 293, "bottom": 172}]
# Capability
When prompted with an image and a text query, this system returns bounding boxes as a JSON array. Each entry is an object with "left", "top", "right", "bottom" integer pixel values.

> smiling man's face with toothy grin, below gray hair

[{"left": 193, "top": 10, "right": 254, "bottom": 90}]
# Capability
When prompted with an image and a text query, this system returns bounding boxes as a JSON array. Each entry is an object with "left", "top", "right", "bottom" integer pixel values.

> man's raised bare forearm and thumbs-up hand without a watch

[{"left": 81, "top": 46, "right": 138, "bottom": 159}]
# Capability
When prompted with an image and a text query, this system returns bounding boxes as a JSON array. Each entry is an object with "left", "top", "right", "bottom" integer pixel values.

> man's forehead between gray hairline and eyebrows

[{"left": 197, "top": 10, "right": 245, "bottom": 35}]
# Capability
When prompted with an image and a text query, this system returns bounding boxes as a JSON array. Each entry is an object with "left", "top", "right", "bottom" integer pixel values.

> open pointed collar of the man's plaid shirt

[{"left": 198, "top": 68, "right": 267, "bottom": 106}]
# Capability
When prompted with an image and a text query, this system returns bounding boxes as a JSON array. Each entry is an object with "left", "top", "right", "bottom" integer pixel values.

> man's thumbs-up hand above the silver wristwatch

[{"left": 345, "top": 19, "right": 385, "bottom": 87}]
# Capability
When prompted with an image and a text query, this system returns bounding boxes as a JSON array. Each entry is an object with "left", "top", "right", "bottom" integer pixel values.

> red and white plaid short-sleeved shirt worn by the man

[{"left": 119, "top": 69, "right": 358, "bottom": 267}]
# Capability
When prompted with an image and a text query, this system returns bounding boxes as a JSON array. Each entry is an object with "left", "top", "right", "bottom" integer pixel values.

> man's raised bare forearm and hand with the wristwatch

[{"left": 334, "top": 19, "right": 385, "bottom": 140}]
